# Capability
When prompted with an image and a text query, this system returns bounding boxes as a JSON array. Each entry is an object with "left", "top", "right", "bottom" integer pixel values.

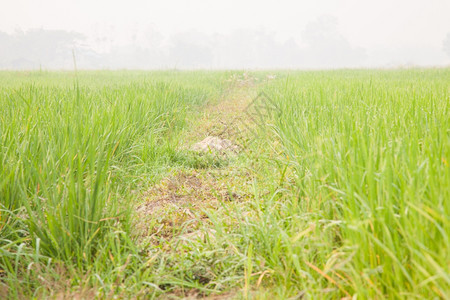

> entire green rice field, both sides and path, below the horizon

[{"left": 0, "top": 69, "right": 450, "bottom": 299}]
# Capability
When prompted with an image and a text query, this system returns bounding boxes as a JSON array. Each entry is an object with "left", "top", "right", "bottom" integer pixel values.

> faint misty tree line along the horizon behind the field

[{"left": 0, "top": 25, "right": 450, "bottom": 69}]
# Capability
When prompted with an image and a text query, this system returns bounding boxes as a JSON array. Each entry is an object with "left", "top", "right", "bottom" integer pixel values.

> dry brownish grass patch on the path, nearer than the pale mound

[{"left": 136, "top": 170, "right": 249, "bottom": 244}]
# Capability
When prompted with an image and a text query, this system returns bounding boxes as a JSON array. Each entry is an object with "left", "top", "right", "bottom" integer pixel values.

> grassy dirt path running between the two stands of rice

[{"left": 129, "top": 73, "right": 282, "bottom": 299}]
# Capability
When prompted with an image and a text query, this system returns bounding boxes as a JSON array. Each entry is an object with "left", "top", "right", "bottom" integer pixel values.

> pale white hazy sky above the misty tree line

[{"left": 0, "top": 0, "right": 450, "bottom": 68}]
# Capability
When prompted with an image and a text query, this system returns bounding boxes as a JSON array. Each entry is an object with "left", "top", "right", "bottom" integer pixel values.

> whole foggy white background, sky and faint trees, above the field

[{"left": 0, "top": 0, "right": 450, "bottom": 69}]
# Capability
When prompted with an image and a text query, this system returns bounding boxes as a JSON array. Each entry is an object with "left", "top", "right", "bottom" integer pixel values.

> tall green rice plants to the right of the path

[{"left": 255, "top": 69, "right": 450, "bottom": 298}]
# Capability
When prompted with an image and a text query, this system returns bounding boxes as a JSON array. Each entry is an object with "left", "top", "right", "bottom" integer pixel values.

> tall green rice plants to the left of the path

[{"left": 0, "top": 72, "right": 229, "bottom": 296}]
